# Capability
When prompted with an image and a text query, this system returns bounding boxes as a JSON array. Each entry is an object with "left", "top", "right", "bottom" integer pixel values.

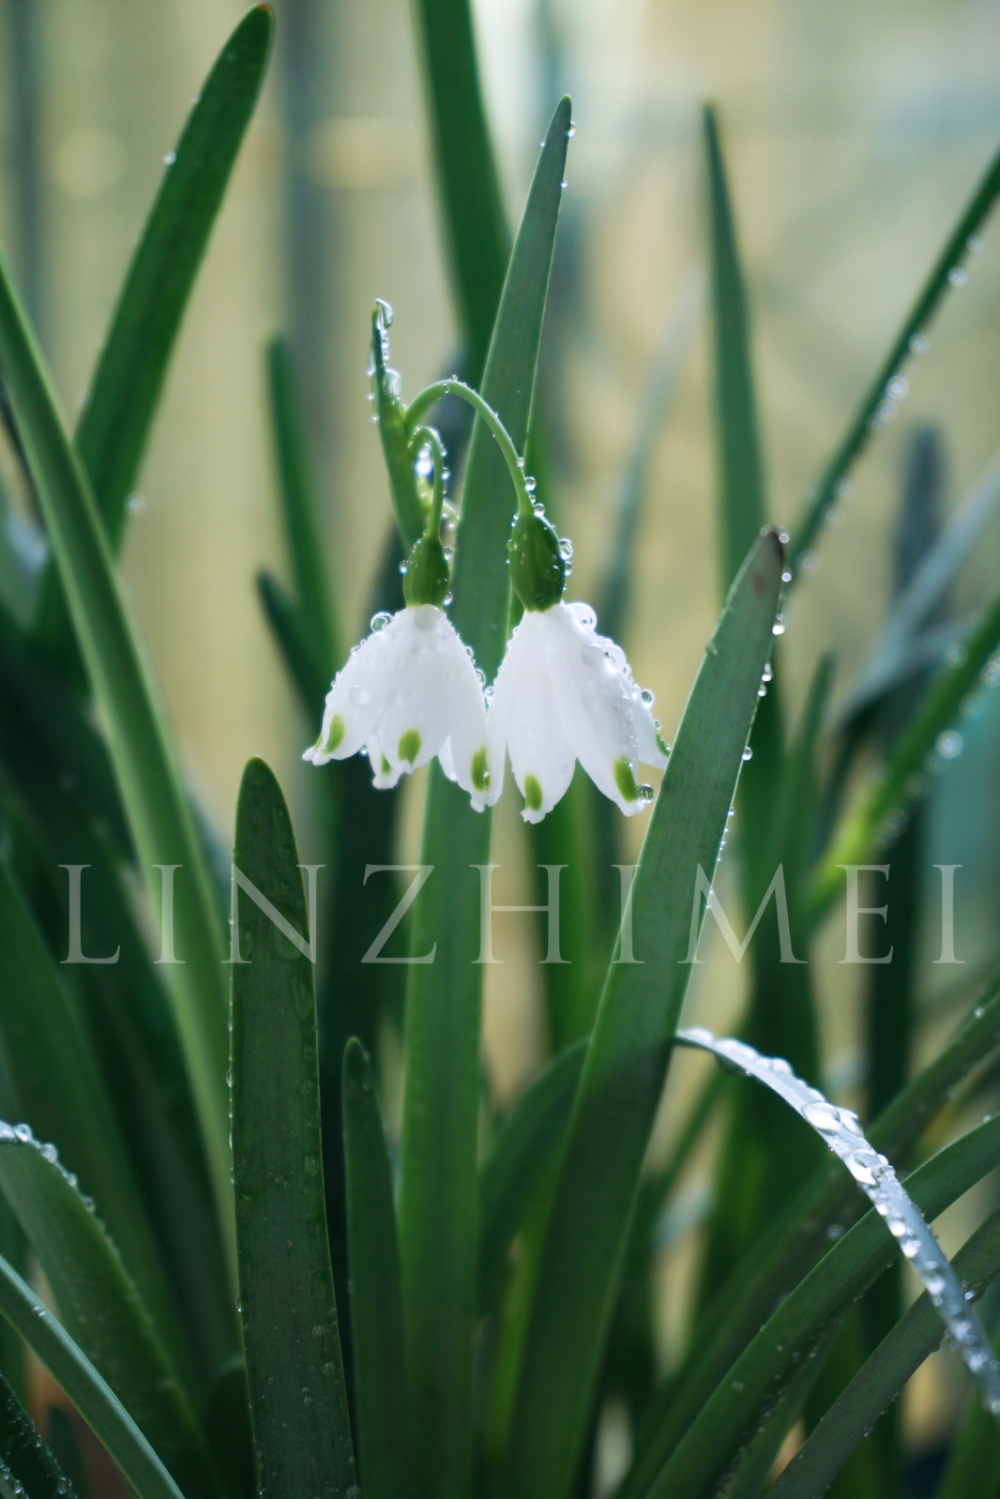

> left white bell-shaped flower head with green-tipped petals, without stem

[{"left": 303, "top": 604, "right": 489, "bottom": 811}]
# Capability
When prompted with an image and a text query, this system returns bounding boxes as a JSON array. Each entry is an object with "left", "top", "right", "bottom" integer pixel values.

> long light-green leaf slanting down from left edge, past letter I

[{"left": 0, "top": 245, "right": 232, "bottom": 1265}]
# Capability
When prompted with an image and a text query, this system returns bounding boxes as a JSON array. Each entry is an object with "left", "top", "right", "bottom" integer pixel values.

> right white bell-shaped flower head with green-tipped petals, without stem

[{"left": 487, "top": 603, "right": 667, "bottom": 823}]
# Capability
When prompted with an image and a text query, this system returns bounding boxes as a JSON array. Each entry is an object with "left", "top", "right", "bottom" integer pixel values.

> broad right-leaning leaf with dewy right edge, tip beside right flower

[{"left": 505, "top": 532, "right": 784, "bottom": 1499}]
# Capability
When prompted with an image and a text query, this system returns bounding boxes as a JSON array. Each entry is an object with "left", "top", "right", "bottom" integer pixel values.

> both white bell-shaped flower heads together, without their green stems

[{"left": 304, "top": 601, "right": 667, "bottom": 823}]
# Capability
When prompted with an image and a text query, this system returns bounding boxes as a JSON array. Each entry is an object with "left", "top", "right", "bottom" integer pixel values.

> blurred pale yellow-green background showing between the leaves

[{"left": 0, "top": 0, "right": 1000, "bottom": 1475}]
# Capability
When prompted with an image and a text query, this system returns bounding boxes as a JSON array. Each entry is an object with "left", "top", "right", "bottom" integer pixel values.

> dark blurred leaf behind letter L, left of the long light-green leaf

[{"left": 0, "top": 590, "right": 237, "bottom": 1378}]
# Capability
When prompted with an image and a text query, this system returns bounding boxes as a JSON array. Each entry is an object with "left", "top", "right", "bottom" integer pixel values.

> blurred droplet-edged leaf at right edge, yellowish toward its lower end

[{"left": 808, "top": 578, "right": 1000, "bottom": 922}]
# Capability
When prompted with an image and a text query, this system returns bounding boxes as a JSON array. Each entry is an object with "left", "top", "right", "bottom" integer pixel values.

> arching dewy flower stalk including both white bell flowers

[{"left": 304, "top": 303, "right": 669, "bottom": 823}]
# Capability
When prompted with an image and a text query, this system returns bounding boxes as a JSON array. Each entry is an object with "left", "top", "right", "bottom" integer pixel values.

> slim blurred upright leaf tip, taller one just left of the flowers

[{"left": 259, "top": 339, "right": 343, "bottom": 682}]
